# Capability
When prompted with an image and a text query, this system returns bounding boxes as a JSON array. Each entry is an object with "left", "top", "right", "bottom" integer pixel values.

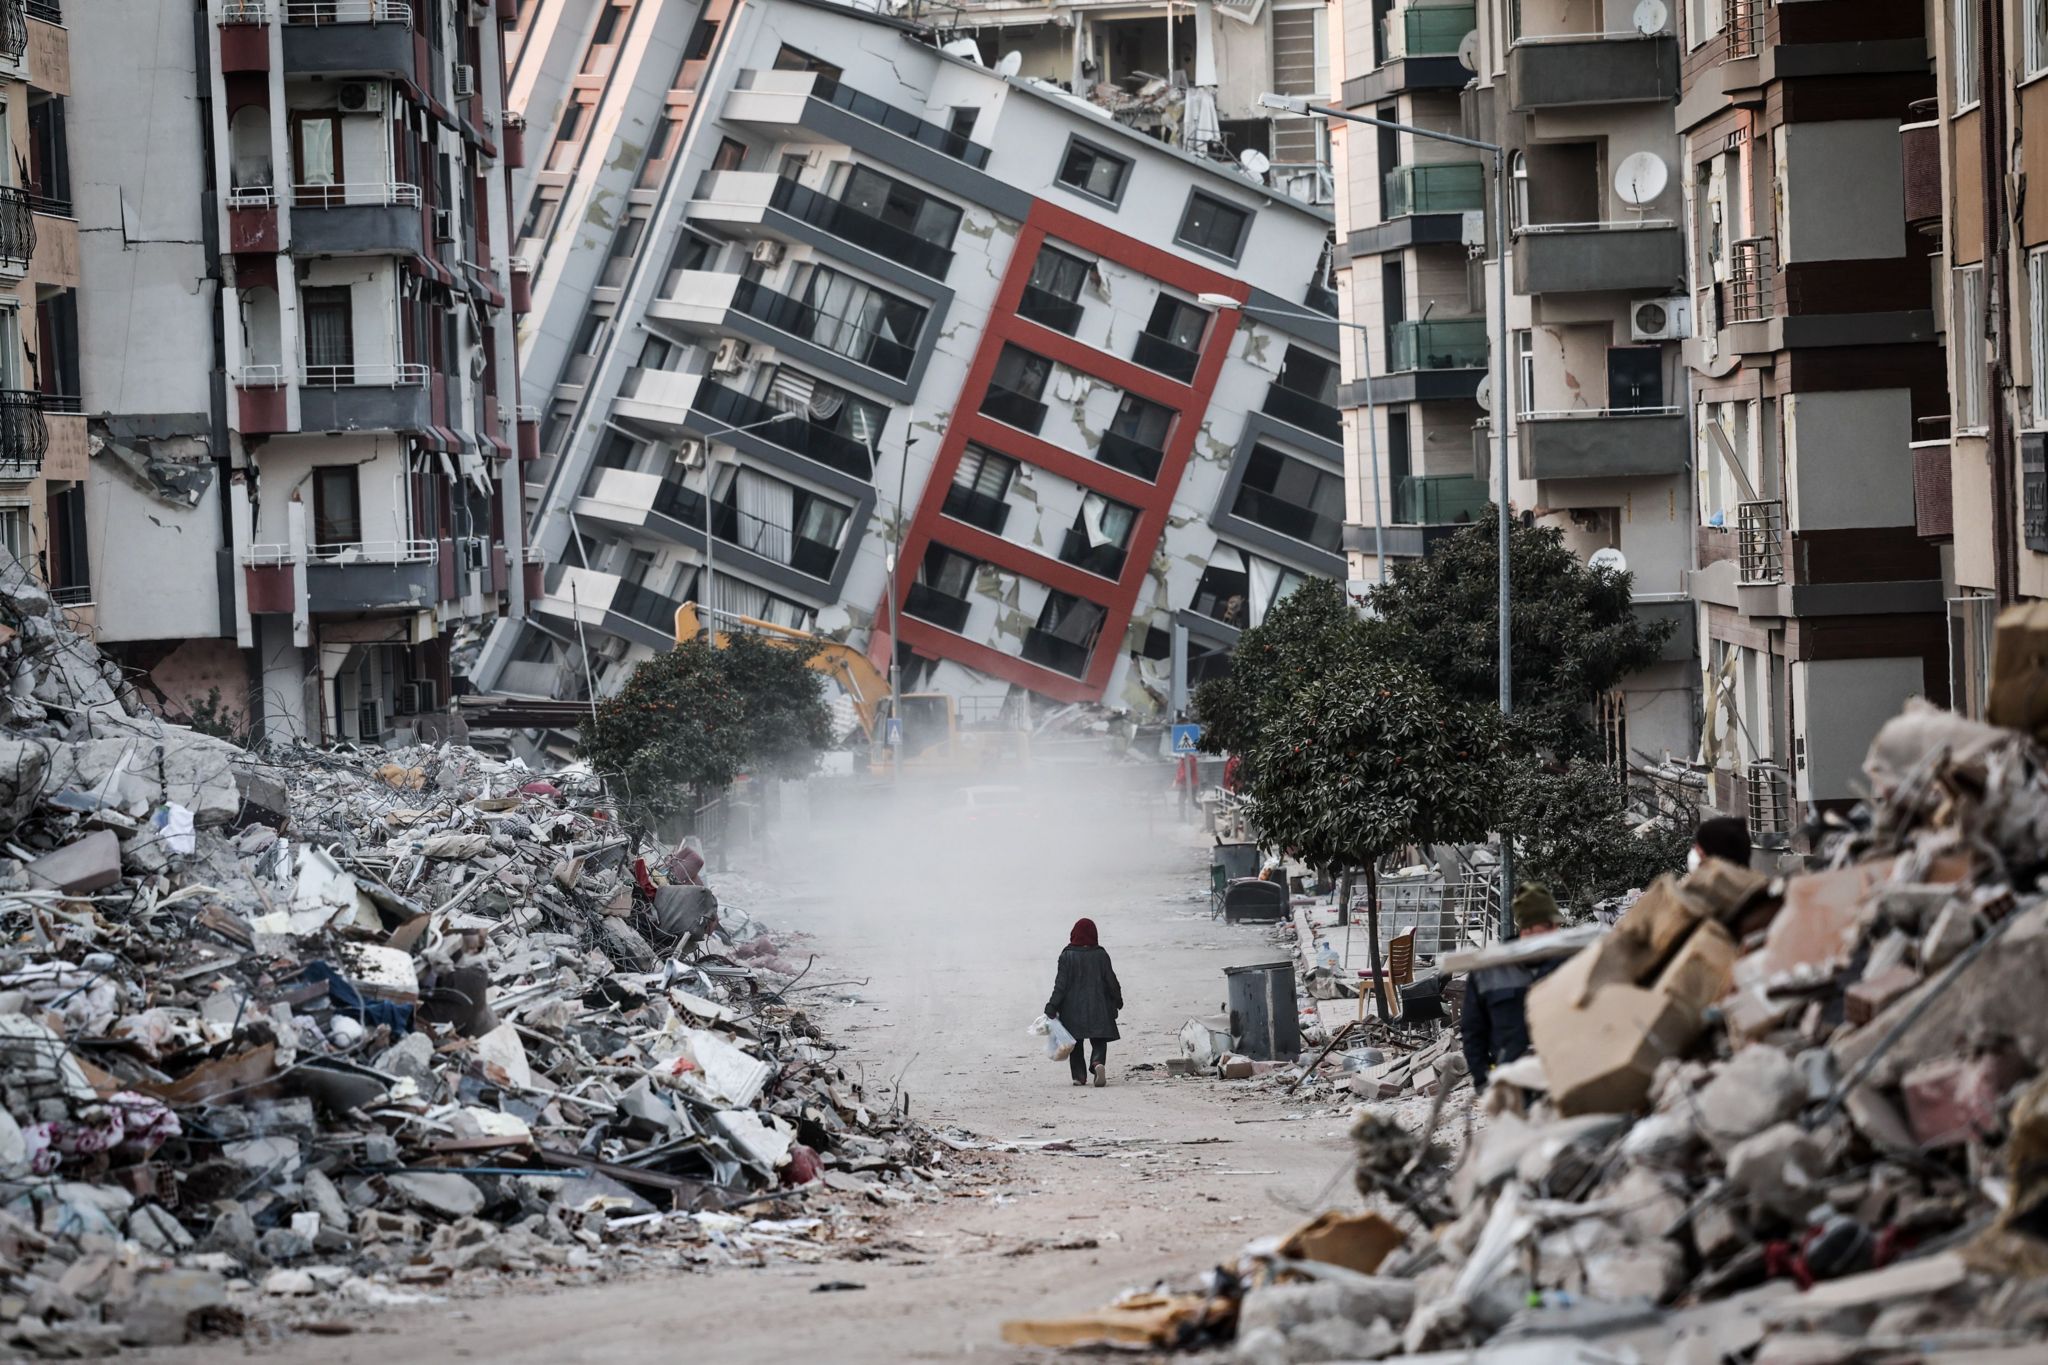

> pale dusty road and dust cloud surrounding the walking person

[{"left": 148, "top": 786, "right": 1350, "bottom": 1365}]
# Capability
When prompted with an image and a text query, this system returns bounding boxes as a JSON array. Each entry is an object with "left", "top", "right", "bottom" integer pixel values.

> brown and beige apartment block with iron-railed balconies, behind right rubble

[{"left": 1677, "top": 0, "right": 1950, "bottom": 843}]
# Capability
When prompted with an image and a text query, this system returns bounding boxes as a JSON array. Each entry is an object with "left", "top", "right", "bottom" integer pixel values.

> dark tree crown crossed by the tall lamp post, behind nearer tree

[{"left": 1370, "top": 514, "right": 1671, "bottom": 757}]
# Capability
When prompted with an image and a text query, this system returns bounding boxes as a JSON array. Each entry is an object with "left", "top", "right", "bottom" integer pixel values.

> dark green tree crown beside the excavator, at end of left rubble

[{"left": 582, "top": 634, "right": 831, "bottom": 823}]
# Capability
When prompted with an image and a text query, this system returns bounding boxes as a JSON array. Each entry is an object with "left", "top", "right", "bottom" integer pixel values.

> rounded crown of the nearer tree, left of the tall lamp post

[{"left": 1249, "top": 653, "right": 1501, "bottom": 868}]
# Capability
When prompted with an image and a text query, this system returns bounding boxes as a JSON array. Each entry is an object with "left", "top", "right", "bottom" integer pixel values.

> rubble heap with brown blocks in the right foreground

[{"left": 1016, "top": 704, "right": 2048, "bottom": 1365}]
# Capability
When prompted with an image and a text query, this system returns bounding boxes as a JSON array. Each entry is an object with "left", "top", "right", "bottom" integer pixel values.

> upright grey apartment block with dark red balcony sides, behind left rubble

[{"left": 72, "top": 0, "right": 522, "bottom": 741}]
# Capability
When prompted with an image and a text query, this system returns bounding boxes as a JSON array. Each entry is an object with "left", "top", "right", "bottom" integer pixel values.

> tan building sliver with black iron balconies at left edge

[{"left": 0, "top": 0, "right": 92, "bottom": 624}]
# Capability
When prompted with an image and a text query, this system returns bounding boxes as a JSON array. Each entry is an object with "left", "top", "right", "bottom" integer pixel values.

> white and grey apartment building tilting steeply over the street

[{"left": 481, "top": 0, "right": 1343, "bottom": 712}]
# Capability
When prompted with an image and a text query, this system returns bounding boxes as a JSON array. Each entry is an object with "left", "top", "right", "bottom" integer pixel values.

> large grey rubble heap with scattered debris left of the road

[{"left": 0, "top": 567, "right": 948, "bottom": 1355}]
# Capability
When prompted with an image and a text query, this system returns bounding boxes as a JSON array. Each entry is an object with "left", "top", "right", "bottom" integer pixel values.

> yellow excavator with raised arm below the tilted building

[{"left": 676, "top": 602, "right": 1030, "bottom": 776}]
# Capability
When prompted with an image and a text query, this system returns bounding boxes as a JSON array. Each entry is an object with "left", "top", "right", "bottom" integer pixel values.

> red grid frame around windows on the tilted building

[{"left": 868, "top": 201, "right": 1249, "bottom": 702}]
